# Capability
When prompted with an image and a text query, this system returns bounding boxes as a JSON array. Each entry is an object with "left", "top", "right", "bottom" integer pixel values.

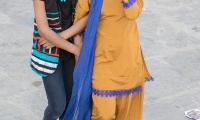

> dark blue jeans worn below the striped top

[{"left": 42, "top": 57, "right": 75, "bottom": 120}]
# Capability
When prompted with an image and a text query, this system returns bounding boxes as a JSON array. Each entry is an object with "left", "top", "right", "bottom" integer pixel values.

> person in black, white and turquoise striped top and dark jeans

[{"left": 30, "top": 0, "right": 87, "bottom": 120}]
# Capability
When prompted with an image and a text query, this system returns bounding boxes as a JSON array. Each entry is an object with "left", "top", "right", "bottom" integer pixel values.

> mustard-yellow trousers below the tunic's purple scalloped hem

[{"left": 91, "top": 82, "right": 144, "bottom": 120}]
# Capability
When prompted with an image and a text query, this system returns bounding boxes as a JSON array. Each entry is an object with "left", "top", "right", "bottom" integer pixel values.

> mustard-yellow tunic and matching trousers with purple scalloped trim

[{"left": 75, "top": 0, "right": 151, "bottom": 120}]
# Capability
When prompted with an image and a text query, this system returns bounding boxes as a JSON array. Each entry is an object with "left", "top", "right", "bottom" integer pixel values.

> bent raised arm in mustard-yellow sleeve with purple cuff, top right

[{"left": 123, "top": 0, "right": 144, "bottom": 20}]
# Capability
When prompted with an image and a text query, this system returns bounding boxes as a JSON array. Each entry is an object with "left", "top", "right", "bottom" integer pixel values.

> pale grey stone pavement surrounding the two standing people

[{"left": 0, "top": 0, "right": 200, "bottom": 120}]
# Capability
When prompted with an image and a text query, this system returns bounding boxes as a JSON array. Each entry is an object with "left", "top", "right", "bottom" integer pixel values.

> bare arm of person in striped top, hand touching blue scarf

[{"left": 33, "top": 0, "right": 80, "bottom": 56}]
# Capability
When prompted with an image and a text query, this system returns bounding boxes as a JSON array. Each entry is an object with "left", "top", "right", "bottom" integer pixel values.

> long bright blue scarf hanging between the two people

[{"left": 58, "top": 0, "right": 103, "bottom": 120}]
